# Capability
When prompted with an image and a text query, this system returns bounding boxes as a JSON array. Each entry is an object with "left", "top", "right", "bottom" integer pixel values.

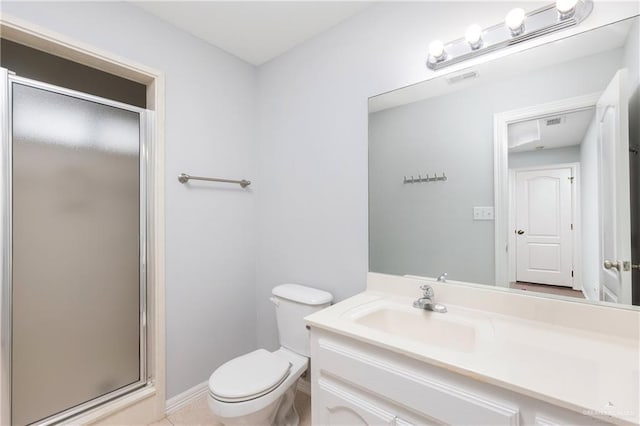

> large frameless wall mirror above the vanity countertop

[{"left": 369, "top": 17, "right": 640, "bottom": 305}]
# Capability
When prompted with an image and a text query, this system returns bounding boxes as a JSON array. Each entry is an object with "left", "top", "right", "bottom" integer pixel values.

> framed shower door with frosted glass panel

[{"left": 0, "top": 69, "right": 151, "bottom": 425}]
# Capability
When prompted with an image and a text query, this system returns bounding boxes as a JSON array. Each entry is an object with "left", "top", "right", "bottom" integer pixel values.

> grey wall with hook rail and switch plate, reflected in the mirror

[{"left": 369, "top": 49, "right": 623, "bottom": 285}]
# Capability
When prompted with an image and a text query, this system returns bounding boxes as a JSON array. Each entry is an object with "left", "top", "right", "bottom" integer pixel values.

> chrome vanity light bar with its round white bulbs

[{"left": 427, "top": 0, "right": 593, "bottom": 70}]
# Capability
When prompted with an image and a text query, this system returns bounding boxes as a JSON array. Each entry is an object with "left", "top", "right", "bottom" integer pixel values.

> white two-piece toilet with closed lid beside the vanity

[{"left": 207, "top": 284, "right": 333, "bottom": 426}]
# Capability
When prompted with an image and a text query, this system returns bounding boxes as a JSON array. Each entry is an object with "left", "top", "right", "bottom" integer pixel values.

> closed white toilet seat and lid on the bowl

[{"left": 209, "top": 349, "right": 291, "bottom": 402}]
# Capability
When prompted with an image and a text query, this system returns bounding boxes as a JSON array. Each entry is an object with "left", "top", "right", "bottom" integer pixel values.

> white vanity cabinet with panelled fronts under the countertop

[{"left": 311, "top": 327, "right": 607, "bottom": 426}]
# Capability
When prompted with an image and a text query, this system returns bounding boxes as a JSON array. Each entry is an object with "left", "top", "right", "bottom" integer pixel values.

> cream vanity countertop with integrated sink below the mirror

[{"left": 306, "top": 274, "right": 640, "bottom": 424}]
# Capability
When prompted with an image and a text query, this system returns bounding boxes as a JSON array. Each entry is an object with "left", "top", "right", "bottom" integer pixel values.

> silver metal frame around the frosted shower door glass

[{"left": 0, "top": 68, "right": 153, "bottom": 426}]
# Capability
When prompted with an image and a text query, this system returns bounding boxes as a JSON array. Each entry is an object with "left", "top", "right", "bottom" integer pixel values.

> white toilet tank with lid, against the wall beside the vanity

[{"left": 271, "top": 284, "right": 333, "bottom": 357}]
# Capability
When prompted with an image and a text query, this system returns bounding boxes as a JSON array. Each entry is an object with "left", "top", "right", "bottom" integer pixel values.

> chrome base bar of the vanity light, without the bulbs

[{"left": 427, "top": 0, "right": 593, "bottom": 70}]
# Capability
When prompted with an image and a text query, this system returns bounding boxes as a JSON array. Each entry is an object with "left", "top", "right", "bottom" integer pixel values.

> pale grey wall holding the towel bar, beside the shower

[{"left": 2, "top": 2, "right": 258, "bottom": 397}]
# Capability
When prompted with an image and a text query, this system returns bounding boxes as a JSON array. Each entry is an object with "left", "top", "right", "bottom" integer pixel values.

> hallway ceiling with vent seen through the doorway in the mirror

[{"left": 508, "top": 108, "right": 595, "bottom": 153}]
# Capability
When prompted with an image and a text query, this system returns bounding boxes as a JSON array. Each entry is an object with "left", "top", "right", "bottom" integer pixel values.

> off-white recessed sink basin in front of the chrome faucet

[{"left": 353, "top": 305, "right": 476, "bottom": 352}]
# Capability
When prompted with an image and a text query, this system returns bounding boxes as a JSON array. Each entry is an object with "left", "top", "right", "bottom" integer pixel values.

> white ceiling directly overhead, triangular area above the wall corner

[{"left": 134, "top": 1, "right": 372, "bottom": 65}]
